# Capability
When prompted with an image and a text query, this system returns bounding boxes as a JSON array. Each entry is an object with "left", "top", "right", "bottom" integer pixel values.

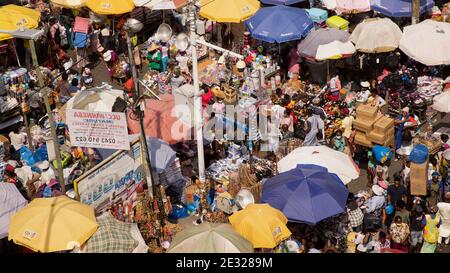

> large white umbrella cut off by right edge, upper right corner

[{"left": 400, "top": 20, "right": 450, "bottom": 66}]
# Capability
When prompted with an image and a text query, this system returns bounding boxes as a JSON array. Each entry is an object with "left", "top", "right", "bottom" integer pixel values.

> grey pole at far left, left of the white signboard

[{"left": 29, "top": 40, "right": 66, "bottom": 192}]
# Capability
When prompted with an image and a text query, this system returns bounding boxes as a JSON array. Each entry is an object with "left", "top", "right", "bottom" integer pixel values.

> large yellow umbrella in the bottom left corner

[{"left": 8, "top": 196, "right": 98, "bottom": 252}]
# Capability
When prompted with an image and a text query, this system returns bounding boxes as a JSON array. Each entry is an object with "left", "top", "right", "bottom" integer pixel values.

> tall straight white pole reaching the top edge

[{"left": 189, "top": 0, "right": 206, "bottom": 183}]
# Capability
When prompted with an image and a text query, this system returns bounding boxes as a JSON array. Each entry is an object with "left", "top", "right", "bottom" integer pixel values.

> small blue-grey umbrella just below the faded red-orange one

[{"left": 147, "top": 137, "right": 177, "bottom": 173}]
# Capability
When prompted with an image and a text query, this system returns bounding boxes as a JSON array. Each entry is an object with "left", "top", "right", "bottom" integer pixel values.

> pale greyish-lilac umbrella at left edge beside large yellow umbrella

[{"left": 0, "top": 183, "right": 28, "bottom": 239}]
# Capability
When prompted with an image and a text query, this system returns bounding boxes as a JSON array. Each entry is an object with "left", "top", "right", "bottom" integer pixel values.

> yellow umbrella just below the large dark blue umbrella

[{"left": 228, "top": 204, "right": 291, "bottom": 248}]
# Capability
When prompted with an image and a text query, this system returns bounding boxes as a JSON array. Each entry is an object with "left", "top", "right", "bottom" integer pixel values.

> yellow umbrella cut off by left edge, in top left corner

[{"left": 0, "top": 6, "right": 39, "bottom": 41}]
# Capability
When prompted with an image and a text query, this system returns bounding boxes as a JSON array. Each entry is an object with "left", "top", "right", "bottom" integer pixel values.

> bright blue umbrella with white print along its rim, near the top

[{"left": 245, "top": 6, "right": 314, "bottom": 43}]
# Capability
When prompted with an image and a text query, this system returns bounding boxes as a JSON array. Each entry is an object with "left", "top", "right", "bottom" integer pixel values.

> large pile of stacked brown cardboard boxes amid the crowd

[{"left": 353, "top": 104, "right": 395, "bottom": 147}]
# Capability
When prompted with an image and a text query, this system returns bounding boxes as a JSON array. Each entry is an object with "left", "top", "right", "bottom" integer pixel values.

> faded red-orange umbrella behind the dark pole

[{"left": 128, "top": 94, "right": 192, "bottom": 144}]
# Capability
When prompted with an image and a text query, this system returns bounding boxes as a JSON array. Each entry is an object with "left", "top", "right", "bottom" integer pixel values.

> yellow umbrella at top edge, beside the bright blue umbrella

[{"left": 199, "top": 0, "right": 260, "bottom": 23}]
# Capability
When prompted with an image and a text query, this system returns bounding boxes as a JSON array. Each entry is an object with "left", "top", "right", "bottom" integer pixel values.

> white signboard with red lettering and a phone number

[{"left": 67, "top": 109, "right": 130, "bottom": 150}]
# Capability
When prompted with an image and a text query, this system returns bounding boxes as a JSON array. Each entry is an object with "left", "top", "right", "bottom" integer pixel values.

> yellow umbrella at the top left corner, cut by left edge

[{"left": 0, "top": 5, "right": 41, "bottom": 41}]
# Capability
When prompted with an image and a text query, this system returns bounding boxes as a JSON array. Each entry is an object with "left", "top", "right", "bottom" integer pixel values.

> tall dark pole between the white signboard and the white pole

[{"left": 127, "top": 28, "right": 165, "bottom": 245}]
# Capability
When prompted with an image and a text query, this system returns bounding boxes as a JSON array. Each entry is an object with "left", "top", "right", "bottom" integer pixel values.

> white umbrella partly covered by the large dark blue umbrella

[{"left": 278, "top": 146, "right": 359, "bottom": 185}]
